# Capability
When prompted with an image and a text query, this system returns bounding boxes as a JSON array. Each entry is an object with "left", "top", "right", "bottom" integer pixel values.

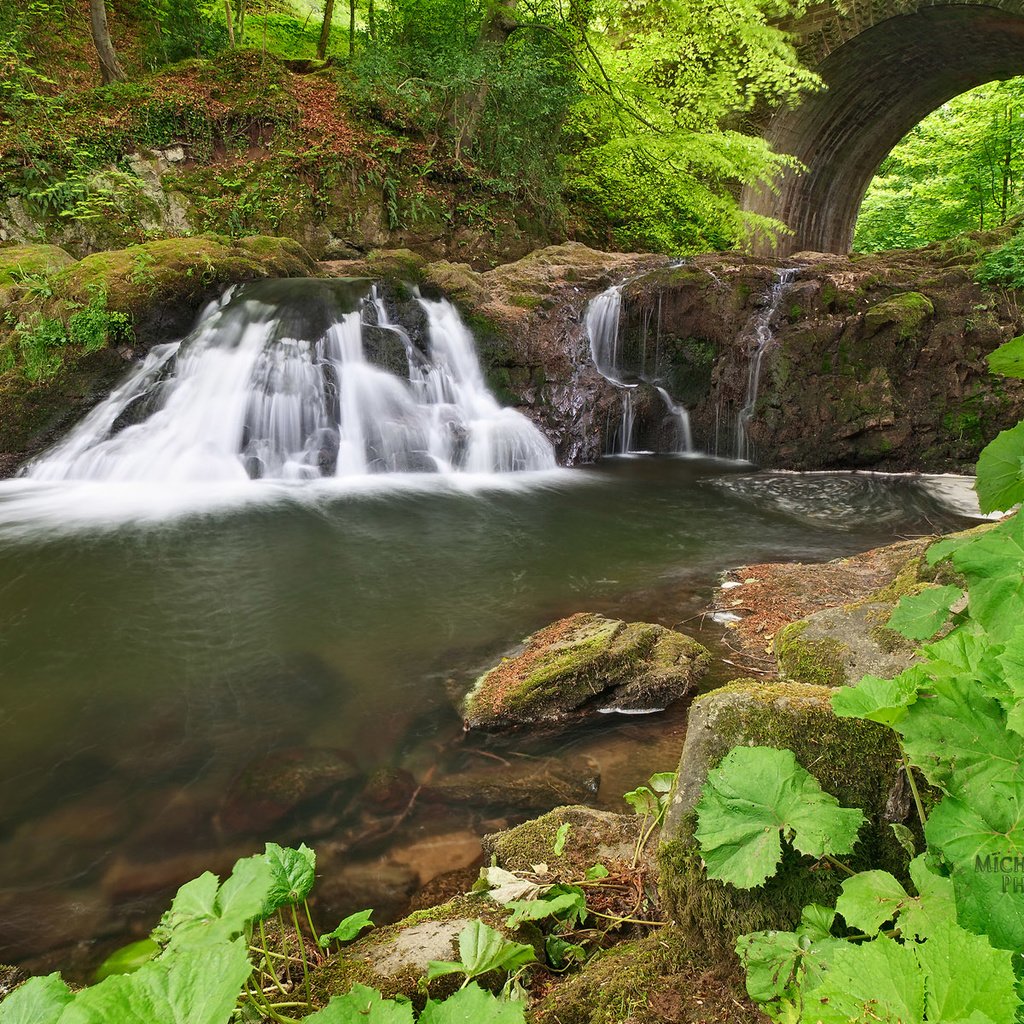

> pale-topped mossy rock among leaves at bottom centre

[{"left": 309, "top": 893, "right": 544, "bottom": 1010}]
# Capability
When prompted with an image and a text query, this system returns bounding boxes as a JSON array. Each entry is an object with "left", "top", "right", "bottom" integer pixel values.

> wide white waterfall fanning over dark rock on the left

[{"left": 25, "top": 281, "right": 555, "bottom": 482}]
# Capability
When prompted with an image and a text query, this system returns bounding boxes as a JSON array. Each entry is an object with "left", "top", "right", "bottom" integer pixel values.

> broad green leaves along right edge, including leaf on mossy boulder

[{"left": 697, "top": 352, "right": 1024, "bottom": 1024}]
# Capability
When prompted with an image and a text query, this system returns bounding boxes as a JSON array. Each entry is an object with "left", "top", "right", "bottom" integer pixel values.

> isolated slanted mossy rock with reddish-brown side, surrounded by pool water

[{"left": 463, "top": 612, "right": 711, "bottom": 730}]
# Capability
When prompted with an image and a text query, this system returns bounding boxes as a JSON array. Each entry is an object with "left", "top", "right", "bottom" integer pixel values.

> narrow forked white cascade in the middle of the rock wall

[{"left": 586, "top": 285, "right": 693, "bottom": 455}]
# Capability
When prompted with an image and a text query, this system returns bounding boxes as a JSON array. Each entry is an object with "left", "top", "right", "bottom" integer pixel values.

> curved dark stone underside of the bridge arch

[{"left": 743, "top": 5, "right": 1024, "bottom": 255}]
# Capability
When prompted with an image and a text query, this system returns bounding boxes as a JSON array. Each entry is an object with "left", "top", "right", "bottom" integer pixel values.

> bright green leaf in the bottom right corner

[{"left": 914, "top": 922, "right": 1020, "bottom": 1022}]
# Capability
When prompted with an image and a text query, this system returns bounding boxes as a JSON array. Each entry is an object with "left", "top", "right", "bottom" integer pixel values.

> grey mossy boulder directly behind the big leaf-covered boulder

[{"left": 775, "top": 601, "right": 915, "bottom": 686}]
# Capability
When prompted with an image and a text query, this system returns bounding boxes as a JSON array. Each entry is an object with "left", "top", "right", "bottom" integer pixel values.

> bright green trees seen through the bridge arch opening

[{"left": 854, "top": 78, "right": 1024, "bottom": 251}]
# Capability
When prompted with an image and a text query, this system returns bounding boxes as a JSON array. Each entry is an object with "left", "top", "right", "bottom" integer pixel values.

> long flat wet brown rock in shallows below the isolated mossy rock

[{"left": 420, "top": 757, "right": 601, "bottom": 811}]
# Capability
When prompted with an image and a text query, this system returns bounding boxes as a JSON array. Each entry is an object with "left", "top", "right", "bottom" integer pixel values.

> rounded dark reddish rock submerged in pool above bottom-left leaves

[{"left": 218, "top": 748, "right": 362, "bottom": 836}]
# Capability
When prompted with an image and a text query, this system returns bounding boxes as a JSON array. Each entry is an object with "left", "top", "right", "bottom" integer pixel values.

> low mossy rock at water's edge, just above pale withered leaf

[{"left": 482, "top": 806, "right": 641, "bottom": 882}]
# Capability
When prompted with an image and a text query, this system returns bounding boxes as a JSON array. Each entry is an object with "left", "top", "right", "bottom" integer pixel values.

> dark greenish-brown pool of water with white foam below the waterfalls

[{"left": 0, "top": 458, "right": 965, "bottom": 976}]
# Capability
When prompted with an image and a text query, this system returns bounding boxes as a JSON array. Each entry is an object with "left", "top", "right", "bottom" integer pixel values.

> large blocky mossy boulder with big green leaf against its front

[{"left": 658, "top": 679, "right": 913, "bottom": 949}]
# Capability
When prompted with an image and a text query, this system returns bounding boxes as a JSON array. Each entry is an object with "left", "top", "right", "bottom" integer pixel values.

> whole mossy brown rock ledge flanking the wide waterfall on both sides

[{"left": 0, "top": 230, "right": 1024, "bottom": 474}]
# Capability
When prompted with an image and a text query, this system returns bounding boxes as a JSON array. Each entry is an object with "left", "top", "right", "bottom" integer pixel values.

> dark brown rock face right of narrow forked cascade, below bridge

[{"left": 620, "top": 243, "right": 1024, "bottom": 471}]
